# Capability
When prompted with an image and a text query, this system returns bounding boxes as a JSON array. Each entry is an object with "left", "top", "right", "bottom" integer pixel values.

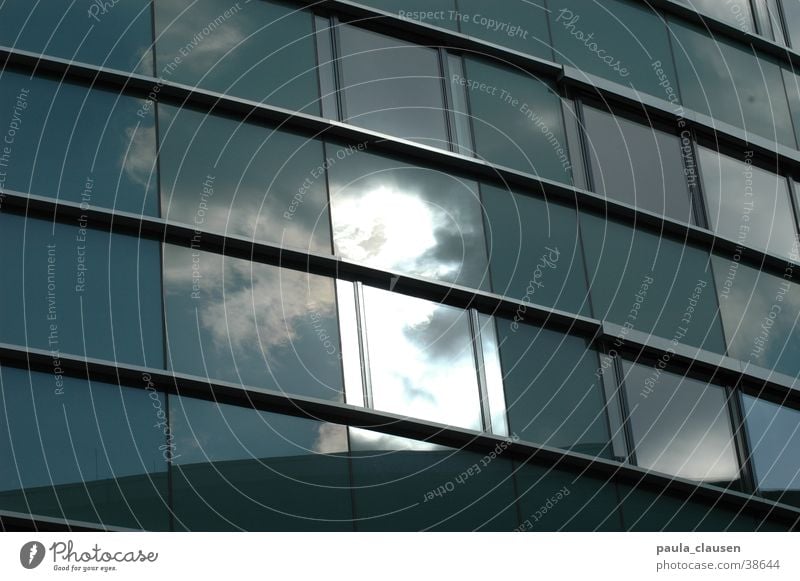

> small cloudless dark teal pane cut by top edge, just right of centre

[{"left": 458, "top": 0, "right": 553, "bottom": 60}]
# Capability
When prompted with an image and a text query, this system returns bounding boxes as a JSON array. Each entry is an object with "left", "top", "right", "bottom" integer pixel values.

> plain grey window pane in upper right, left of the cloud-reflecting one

[{"left": 583, "top": 107, "right": 694, "bottom": 223}]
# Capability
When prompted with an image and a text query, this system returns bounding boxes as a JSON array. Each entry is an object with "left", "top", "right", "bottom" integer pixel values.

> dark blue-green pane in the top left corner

[{"left": 0, "top": 0, "right": 153, "bottom": 74}]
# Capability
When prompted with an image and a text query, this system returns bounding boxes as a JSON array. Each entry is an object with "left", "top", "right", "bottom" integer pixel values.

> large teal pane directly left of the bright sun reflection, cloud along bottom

[{"left": 159, "top": 105, "right": 331, "bottom": 253}]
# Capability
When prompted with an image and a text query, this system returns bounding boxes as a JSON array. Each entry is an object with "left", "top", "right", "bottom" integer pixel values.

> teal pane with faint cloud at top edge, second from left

[{"left": 155, "top": 0, "right": 320, "bottom": 115}]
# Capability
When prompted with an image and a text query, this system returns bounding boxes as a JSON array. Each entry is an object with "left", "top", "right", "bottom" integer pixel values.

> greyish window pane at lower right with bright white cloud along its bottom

[{"left": 622, "top": 361, "right": 739, "bottom": 487}]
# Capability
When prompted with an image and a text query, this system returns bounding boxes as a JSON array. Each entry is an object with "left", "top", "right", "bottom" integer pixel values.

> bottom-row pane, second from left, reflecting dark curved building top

[{"left": 170, "top": 396, "right": 353, "bottom": 531}]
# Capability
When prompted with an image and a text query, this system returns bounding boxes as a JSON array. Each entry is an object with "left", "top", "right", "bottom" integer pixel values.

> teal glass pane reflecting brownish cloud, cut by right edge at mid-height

[{"left": 713, "top": 254, "right": 800, "bottom": 377}]
